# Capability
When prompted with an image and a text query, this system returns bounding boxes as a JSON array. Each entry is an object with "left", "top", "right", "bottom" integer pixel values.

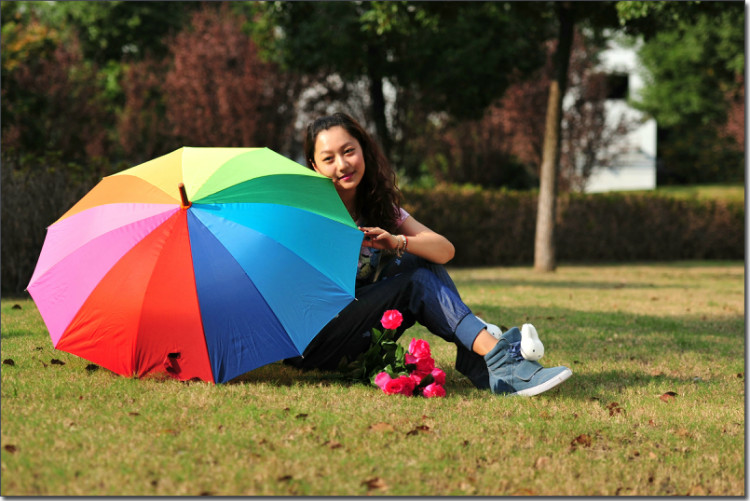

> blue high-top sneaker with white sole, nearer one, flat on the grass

[{"left": 484, "top": 327, "right": 573, "bottom": 397}]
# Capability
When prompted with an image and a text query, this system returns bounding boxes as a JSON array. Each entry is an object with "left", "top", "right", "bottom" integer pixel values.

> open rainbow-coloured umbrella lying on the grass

[{"left": 28, "top": 147, "right": 362, "bottom": 382}]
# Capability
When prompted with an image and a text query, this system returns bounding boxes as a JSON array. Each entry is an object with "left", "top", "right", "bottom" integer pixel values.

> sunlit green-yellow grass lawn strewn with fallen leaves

[{"left": 0, "top": 262, "right": 745, "bottom": 496}]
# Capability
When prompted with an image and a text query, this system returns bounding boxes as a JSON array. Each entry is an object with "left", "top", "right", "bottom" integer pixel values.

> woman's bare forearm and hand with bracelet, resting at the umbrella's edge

[{"left": 360, "top": 216, "right": 456, "bottom": 264}]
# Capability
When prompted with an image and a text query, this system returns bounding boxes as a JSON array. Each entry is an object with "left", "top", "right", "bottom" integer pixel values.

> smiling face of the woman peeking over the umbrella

[{"left": 313, "top": 125, "right": 365, "bottom": 199}]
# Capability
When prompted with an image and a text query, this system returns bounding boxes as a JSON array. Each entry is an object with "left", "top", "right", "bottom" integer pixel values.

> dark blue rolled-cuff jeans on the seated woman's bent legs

[{"left": 286, "top": 253, "right": 489, "bottom": 388}]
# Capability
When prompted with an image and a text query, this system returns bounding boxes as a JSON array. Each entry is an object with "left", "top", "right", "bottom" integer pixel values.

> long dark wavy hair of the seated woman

[{"left": 305, "top": 113, "right": 401, "bottom": 232}]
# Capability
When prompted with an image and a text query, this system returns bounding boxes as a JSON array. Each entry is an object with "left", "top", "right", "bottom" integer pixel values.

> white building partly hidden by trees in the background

[{"left": 584, "top": 40, "right": 656, "bottom": 193}]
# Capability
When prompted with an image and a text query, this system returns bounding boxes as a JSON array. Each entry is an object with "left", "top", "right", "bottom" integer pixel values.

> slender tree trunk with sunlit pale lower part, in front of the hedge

[{"left": 534, "top": 2, "right": 575, "bottom": 271}]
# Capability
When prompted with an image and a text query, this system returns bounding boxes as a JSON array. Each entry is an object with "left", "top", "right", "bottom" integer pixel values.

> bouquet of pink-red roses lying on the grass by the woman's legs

[{"left": 349, "top": 310, "right": 445, "bottom": 398}]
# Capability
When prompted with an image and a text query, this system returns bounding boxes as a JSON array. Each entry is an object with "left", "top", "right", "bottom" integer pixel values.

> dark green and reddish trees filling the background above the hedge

[{"left": 0, "top": 1, "right": 745, "bottom": 292}]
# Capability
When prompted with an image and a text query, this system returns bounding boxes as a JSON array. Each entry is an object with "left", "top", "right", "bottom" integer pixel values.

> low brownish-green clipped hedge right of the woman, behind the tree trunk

[{"left": 403, "top": 187, "right": 745, "bottom": 266}]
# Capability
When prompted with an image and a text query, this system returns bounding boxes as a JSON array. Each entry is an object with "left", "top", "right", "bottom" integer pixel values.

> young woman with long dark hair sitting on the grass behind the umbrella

[{"left": 288, "top": 113, "right": 572, "bottom": 396}]
